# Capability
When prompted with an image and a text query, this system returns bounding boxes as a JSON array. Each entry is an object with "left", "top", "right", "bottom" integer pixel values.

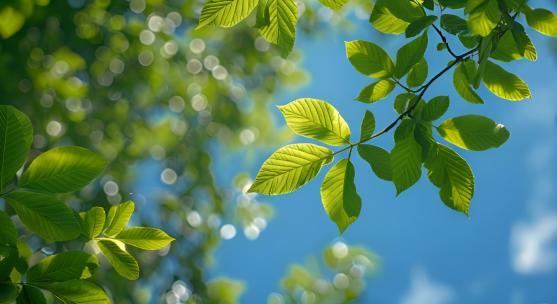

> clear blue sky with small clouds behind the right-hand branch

[{"left": 210, "top": 1, "right": 557, "bottom": 304}]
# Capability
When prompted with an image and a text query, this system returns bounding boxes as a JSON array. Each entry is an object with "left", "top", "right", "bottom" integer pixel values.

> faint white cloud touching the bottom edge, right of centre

[{"left": 400, "top": 269, "right": 455, "bottom": 304}]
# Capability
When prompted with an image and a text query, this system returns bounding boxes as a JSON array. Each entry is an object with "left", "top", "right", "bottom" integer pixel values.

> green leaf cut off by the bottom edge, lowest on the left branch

[{"left": 39, "top": 280, "right": 112, "bottom": 304}]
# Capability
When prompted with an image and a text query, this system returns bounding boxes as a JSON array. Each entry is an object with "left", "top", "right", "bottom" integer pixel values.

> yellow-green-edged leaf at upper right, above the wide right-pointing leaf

[{"left": 483, "top": 61, "right": 532, "bottom": 101}]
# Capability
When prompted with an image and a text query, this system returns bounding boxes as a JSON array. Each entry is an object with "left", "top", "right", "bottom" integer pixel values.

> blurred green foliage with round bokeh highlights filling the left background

[{"left": 0, "top": 0, "right": 376, "bottom": 303}]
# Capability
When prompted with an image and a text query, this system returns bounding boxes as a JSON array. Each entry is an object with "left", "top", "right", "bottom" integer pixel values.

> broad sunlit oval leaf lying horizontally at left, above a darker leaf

[{"left": 19, "top": 146, "right": 107, "bottom": 193}]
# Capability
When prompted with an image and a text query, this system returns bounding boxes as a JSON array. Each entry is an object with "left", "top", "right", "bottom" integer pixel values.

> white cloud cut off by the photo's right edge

[{"left": 511, "top": 214, "right": 557, "bottom": 274}]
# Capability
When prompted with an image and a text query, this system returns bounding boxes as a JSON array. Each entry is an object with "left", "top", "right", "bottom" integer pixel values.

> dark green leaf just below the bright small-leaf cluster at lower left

[{"left": 27, "top": 251, "right": 99, "bottom": 283}]
